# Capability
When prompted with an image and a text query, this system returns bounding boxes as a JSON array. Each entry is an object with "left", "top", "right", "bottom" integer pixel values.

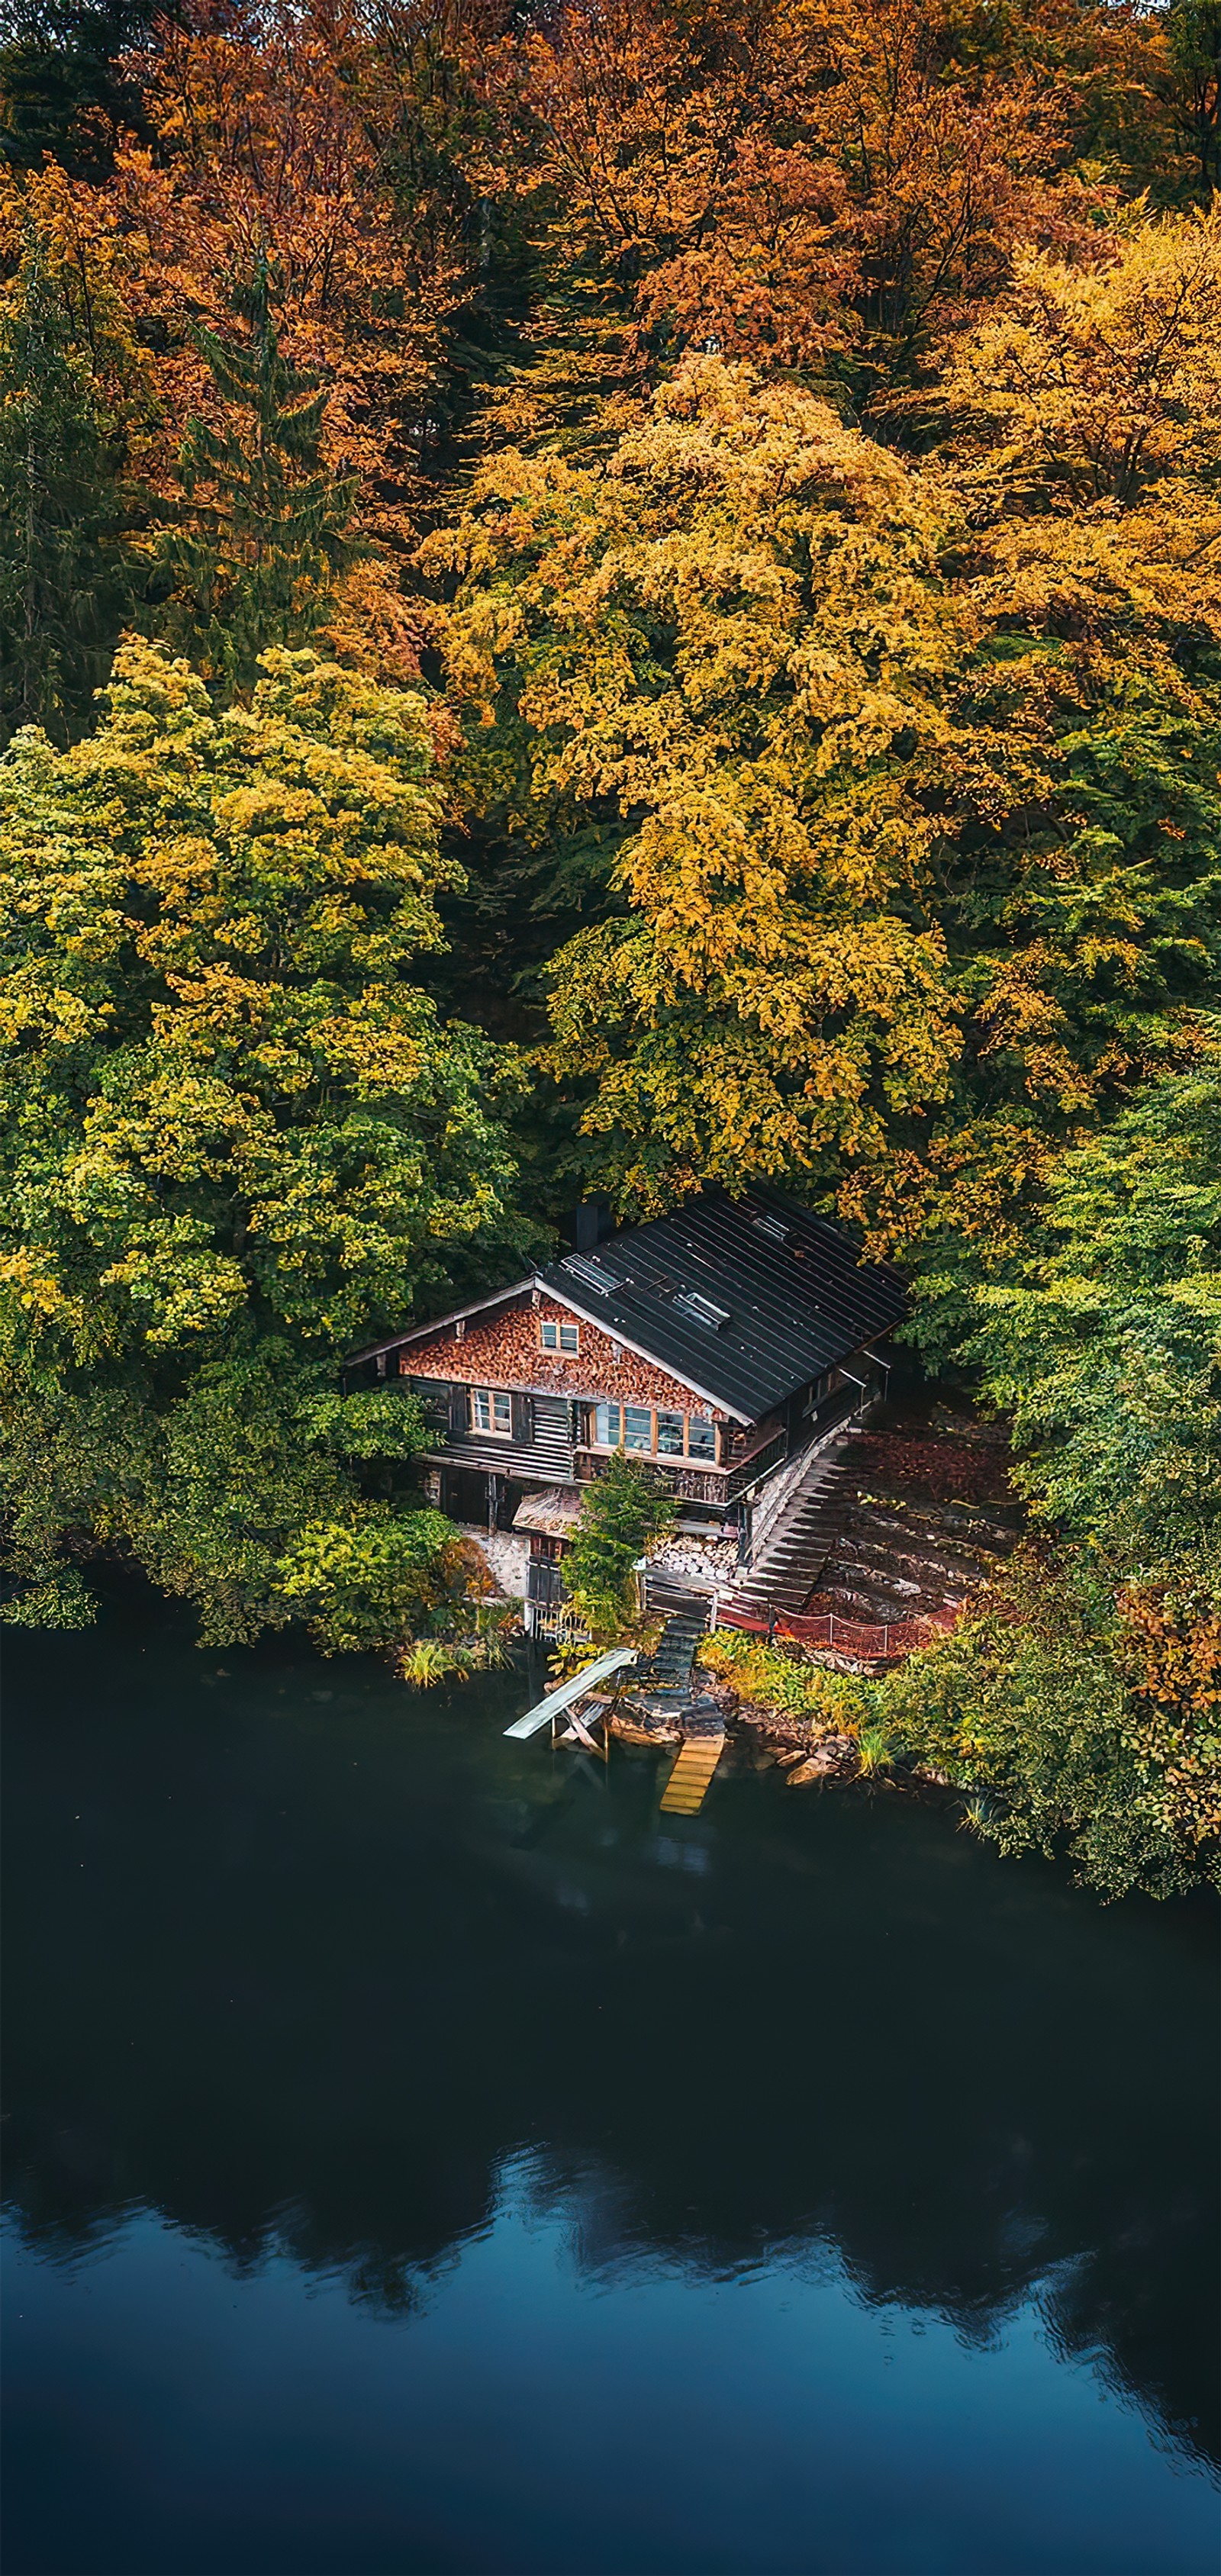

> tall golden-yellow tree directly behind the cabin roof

[{"left": 425, "top": 358, "right": 961, "bottom": 1206}]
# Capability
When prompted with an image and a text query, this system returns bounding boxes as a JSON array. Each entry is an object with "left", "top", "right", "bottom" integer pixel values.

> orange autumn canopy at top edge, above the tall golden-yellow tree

[{"left": 466, "top": 0, "right": 1123, "bottom": 433}]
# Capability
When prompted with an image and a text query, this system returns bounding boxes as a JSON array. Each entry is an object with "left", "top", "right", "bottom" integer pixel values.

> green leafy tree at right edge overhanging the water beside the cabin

[{"left": 884, "top": 1061, "right": 1221, "bottom": 1896}]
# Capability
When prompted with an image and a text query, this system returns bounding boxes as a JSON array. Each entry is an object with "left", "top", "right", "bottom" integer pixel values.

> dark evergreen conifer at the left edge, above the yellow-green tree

[{"left": 0, "top": 227, "right": 129, "bottom": 742}]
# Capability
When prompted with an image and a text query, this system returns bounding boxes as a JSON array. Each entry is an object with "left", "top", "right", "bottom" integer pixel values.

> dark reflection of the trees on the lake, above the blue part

[{"left": 5, "top": 1605, "right": 1219, "bottom": 2455}]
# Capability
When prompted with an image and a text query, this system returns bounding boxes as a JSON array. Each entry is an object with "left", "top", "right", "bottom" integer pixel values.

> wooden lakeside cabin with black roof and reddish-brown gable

[{"left": 348, "top": 1190, "right": 907, "bottom": 1597}]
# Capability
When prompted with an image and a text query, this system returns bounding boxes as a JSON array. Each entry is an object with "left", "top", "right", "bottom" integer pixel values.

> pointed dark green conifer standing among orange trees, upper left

[{"left": 163, "top": 258, "right": 358, "bottom": 693}]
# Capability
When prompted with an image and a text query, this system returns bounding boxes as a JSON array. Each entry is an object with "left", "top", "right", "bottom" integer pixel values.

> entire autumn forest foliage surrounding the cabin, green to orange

[{"left": 0, "top": 0, "right": 1221, "bottom": 1889}]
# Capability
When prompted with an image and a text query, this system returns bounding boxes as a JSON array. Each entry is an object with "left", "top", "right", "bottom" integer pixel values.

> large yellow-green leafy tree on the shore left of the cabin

[{"left": 0, "top": 644, "right": 533, "bottom": 1646}]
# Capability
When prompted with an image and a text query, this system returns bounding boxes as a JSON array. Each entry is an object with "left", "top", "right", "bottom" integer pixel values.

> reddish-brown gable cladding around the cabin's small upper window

[{"left": 402, "top": 1299, "right": 724, "bottom": 1422}]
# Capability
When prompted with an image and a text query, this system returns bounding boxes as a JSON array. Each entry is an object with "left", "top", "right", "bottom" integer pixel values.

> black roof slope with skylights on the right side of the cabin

[{"left": 538, "top": 1190, "right": 907, "bottom": 1422}]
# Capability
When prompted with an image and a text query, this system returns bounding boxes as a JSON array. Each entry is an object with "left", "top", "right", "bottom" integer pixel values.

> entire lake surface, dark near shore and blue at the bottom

[{"left": 2, "top": 1615, "right": 1219, "bottom": 2576}]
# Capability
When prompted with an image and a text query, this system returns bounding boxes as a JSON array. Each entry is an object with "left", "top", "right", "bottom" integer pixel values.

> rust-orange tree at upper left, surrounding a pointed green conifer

[{"left": 103, "top": 5, "right": 456, "bottom": 678}]
